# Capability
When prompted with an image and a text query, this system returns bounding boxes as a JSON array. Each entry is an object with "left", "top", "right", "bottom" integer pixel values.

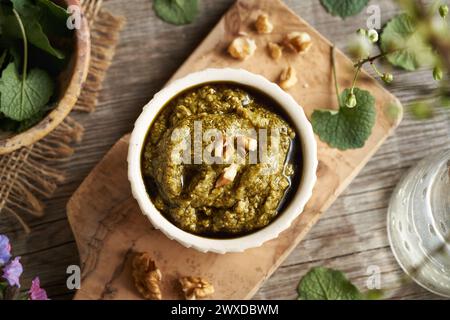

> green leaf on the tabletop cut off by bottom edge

[{"left": 297, "top": 267, "right": 364, "bottom": 300}]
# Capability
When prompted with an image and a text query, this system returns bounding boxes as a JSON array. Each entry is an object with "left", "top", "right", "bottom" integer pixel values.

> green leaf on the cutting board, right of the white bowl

[{"left": 312, "top": 88, "right": 376, "bottom": 150}]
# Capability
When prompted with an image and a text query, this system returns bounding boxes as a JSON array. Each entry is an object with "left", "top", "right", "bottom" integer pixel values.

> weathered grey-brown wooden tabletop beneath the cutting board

[{"left": 0, "top": 0, "right": 450, "bottom": 299}]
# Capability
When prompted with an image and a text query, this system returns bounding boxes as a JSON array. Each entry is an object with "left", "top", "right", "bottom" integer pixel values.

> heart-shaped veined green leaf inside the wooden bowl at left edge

[{"left": 0, "top": 63, "right": 54, "bottom": 121}]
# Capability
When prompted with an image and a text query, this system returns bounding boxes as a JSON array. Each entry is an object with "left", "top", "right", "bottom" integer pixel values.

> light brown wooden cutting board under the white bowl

[{"left": 67, "top": 0, "right": 402, "bottom": 299}]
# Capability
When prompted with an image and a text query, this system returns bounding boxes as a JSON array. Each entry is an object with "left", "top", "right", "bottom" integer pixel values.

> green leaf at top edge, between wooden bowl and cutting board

[{"left": 153, "top": 0, "right": 198, "bottom": 25}]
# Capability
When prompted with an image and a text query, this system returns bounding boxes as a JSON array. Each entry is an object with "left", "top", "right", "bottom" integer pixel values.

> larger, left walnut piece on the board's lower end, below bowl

[{"left": 132, "top": 252, "right": 162, "bottom": 300}]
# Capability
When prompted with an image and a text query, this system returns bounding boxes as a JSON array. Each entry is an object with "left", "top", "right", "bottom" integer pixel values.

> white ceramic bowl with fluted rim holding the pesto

[{"left": 128, "top": 69, "right": 317, "bottom": 253}]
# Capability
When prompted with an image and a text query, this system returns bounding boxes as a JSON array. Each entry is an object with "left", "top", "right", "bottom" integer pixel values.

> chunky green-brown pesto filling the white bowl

[{"left": 142, "top": 82, "right": 302, "bottom": 238}]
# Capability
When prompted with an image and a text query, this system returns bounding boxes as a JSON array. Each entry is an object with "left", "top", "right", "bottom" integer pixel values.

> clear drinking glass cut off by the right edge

[{"left": 387, "top": 150, "right": 450, "bottom": 297}]
